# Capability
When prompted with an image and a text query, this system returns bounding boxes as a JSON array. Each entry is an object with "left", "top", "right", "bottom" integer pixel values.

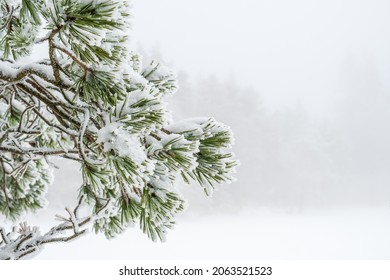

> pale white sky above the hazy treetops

[{"left": 132, "top": 0, "right": 390, "bottom": 114}]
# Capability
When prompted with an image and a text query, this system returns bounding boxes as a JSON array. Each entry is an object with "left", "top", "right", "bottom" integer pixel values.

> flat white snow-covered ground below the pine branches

[{"left": 32, "top": 208, "right": 390, "bottom": 260}]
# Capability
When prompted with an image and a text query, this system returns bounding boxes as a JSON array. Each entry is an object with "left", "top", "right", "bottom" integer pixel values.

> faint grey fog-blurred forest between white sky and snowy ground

[{"left": 165, "top": 58, "right": 390, "bottom": 213}]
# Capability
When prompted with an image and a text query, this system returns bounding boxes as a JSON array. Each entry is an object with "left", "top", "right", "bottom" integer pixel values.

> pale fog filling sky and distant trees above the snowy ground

[{"left": 126, "top": 0, "right": 390, "bottom": 211}]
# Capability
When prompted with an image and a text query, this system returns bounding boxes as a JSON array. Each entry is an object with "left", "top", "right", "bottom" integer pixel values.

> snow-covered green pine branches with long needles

[{"left": 0, "top": 0, "right": 237, "bottom": 259}]
